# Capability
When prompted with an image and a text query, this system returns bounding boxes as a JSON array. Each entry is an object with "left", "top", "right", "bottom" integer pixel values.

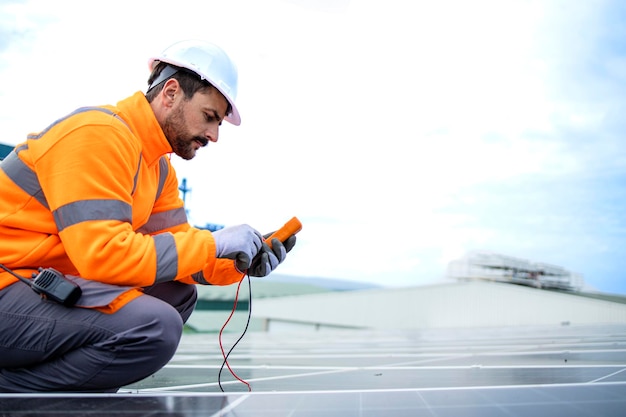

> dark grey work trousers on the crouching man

[{"left": 0, "top": 282, "right": 197, "bottom": 392}]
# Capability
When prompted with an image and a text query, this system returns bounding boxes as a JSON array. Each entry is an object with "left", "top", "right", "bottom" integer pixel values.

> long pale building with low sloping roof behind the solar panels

[{"left": 251, "top": 276, "right": 626, "bottom": 334}]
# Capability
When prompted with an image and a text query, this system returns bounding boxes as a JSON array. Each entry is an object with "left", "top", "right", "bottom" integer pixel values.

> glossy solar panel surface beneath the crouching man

[{"left": 0, "top": 325, "right": 626, "bottom": 417}]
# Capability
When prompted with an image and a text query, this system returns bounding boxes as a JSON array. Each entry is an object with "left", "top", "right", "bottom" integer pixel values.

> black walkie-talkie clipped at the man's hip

[{"left": 0, "top": 264, "right": 83, "bottom": 307}]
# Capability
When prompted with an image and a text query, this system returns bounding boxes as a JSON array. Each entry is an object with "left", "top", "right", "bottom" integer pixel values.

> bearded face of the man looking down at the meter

[{"left": 163, "top": 88, "right": 228, "bottom": 159}]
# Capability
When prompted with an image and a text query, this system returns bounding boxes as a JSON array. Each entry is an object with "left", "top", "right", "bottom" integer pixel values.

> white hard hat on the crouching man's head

[{"left": 148, "top": 40, "right": 241, "bottom": 126}]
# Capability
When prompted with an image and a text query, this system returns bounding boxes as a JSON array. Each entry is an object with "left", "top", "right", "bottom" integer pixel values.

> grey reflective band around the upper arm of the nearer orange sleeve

[{"left": 52, "top": 200, "right": 133, "bottom": 232}]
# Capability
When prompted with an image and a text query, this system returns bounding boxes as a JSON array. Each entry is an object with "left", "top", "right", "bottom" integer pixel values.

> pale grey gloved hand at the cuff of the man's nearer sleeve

[{"left": 213, "top": 224, "right": 267, "bottom": 273}]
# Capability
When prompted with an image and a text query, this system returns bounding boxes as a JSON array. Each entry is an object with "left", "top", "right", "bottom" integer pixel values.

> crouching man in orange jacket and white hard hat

[{"left": 0, "top": 41, "right": 295, "bottom": 392}]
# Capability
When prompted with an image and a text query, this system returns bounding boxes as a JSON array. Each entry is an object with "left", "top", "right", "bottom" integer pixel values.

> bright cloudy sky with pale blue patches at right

[{"left": 0, "top": 0, "right": 626, "bottom": 294}]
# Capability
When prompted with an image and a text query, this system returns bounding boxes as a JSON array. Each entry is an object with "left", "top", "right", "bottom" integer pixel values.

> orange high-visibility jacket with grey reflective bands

[{"left": 0, "top": 92, "right": 241, "bottom": 310}]
